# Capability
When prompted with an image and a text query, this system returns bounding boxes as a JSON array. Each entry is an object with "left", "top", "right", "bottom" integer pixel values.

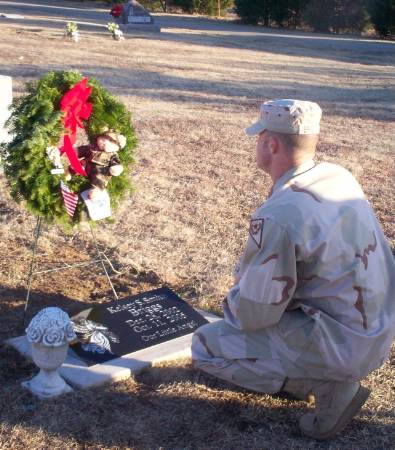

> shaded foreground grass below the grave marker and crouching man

[{"left": 0, "top": 358, "right": 391, "bottom": 449}]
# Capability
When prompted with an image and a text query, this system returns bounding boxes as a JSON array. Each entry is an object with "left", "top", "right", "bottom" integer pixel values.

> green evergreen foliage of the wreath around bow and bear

[{"left": 0, "top": 71, "right": 136, "bottom": 227}]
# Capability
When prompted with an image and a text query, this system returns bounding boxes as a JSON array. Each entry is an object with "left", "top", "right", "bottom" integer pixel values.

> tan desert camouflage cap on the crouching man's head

[{"left": 245, "top": 99, "right": 322, "bottom": 136}]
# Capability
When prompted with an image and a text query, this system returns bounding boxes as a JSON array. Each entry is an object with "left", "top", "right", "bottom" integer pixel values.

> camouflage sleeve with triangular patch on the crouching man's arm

[{"left": 223, "top": 219, "right": 296, "bottom": 331}]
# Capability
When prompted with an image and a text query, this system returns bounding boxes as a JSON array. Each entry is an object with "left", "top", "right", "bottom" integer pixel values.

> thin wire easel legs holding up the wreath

[{"left": 23, "top": 217, "right": 121, "bottom": 327}]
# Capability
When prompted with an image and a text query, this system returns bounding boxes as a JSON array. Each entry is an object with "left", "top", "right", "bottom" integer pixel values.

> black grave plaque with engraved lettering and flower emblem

[{"left": 72, "top": 287, "right": 207, "bottom": 366}]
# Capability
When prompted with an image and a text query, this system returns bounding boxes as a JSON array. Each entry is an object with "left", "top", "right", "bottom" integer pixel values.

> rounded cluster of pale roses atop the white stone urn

[{"left": 26, "top": 307, "right": 76, "bottom": 347}]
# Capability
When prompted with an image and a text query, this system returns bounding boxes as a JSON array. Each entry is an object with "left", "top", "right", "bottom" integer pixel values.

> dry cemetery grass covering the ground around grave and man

[{"left": 0, "top": 2, "right": 395, "bottom": 450}]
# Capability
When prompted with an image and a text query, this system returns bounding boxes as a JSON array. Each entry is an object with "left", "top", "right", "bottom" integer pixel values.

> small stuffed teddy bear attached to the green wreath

[{"left": 77, "top": 130, "right": 126, "bottom": 200}]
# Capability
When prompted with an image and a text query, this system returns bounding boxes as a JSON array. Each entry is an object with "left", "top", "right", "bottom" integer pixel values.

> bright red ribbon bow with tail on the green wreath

[{"left": 60, "top": 78, "right": 92, "bottom": 177}]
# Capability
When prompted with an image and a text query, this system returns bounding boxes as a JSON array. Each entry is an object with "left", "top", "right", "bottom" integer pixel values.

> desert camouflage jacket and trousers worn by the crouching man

[{"left": 192, "top": 161, "right": 395, "bottom": 393}]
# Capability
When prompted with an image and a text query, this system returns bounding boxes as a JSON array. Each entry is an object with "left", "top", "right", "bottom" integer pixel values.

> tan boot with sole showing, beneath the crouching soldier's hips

[{"left": 299, "top": 381, "right": 370, "bottom": 440}]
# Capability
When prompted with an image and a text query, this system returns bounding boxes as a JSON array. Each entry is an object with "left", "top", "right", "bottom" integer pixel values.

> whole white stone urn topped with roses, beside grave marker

[{"left": 22, "top": 307, "right": 76, "bottom": 399}]
